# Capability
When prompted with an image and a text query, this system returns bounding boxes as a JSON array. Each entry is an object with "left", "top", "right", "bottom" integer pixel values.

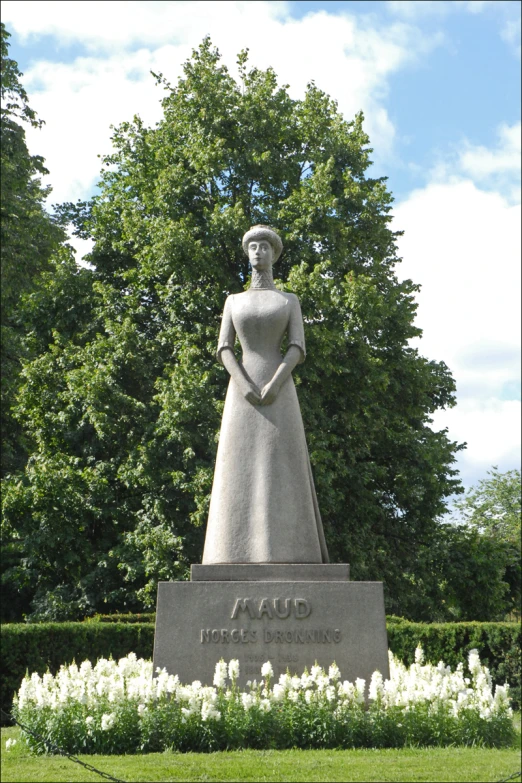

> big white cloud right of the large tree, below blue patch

[{"left": 393, "top": 178, "right": 521, "bottom": 485}]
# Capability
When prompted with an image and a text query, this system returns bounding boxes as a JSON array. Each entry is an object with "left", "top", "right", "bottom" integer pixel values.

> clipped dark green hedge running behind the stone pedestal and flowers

[{"left": 0, "top": 615, "right": 521, "bottom": 724}]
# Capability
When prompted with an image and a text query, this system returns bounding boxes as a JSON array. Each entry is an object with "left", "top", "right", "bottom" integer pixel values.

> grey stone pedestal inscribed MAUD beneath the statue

[{"left": 150, "top": 564, "right": 389, "bottom": 687}]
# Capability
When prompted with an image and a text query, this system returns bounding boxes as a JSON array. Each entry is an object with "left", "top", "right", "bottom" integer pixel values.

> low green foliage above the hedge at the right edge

[{"left": 390, "top": 467, "right": 521, "bottom": 622}]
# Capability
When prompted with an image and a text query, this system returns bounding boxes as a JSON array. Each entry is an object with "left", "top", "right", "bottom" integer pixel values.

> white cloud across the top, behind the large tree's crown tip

[{"left": 3, "top": 0, "right": 440, "bottom": 202}]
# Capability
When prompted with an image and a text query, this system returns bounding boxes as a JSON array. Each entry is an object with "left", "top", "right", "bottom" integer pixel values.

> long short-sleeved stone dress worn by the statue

[{"left": 203, "top": 289, "right": 328, "bottom": 564}]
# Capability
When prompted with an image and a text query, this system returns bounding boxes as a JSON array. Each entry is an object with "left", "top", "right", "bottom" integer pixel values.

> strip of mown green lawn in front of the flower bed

[{"left": 1, "top": 724, "right": 521, "bottom": 783}]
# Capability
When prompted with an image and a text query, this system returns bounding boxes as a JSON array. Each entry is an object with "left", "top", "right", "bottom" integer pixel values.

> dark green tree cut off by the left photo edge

[{"left": 0, "top": 24, "right": 65, "bottom": 476}]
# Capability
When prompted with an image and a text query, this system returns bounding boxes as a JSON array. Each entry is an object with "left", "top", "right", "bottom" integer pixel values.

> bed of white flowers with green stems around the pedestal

[{"left": 14, "top": 648, "right": 513, "bottom": 754}]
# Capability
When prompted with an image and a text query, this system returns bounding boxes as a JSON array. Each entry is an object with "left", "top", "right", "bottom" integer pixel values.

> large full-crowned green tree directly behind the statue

[{"left": 5, "top": 39, "right": 461, "bottom": 618}]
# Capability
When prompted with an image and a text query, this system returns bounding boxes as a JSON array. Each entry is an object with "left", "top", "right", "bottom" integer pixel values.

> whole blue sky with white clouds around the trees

[{"left": 2, "top": 0, "right": 521, "bottom": 496}]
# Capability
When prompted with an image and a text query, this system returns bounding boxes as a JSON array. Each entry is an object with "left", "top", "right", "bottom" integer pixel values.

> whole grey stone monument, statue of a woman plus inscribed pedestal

[{"left": 154, "top": 225, "right": 389, "bottom": 685}]
